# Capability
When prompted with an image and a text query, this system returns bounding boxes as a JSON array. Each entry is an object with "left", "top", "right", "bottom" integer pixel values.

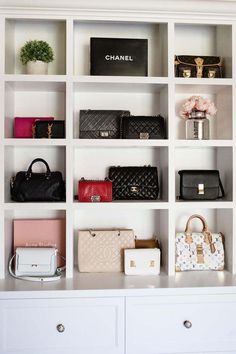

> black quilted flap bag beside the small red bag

[{"left": 109, "top": 166, "right": 159, "bottom": 200}]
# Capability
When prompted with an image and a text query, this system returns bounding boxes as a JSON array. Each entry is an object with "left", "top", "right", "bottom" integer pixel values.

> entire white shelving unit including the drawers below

[{"left": 0, "top": 0, "right": 236, "bottom": 354}]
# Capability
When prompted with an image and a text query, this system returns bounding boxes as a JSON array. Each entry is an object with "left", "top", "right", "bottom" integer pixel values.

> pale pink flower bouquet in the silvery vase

[{"left": 180, "top": 96, "right": 217, "bottom": 119}]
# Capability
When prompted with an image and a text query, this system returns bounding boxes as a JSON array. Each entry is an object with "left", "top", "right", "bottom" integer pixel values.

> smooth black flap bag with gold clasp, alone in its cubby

[{"left": 178, "top": 170, "right": 225, "bottom": 200}]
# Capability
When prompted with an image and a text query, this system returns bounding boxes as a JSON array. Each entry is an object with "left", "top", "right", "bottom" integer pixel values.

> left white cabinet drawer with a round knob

[{"left": 0, "top": 298, "right": 124, "bottom": 354}]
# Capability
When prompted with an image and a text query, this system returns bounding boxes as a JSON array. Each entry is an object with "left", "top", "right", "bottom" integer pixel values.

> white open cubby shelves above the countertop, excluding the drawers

[{"left": 0, "top": 1, "right": 236, "bottom": 285}]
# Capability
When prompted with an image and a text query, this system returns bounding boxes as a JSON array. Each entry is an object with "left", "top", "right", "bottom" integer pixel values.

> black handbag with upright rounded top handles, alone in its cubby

[{"left": 10, "top": 158, "right": 65, "bottom": 202}]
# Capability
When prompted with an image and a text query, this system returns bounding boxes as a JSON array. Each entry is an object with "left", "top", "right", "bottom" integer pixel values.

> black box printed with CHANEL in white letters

[{"left": 90, "top": 38, "right": 148, "bottom": 76}]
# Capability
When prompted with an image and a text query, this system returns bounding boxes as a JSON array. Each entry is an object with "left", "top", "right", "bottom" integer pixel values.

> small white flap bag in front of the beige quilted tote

[{"left": 125, "top": 248, "right": 161, "bottom": 275}]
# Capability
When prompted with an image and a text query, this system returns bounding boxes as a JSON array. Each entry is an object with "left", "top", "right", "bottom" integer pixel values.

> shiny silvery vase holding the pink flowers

[{"left": 185, "top": 111, "right": 210, "bottom": 140}]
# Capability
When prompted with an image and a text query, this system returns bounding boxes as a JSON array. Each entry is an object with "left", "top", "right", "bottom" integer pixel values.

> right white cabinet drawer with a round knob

[{"left": 126, "top": 295, "right": 236, "bottom": 354}]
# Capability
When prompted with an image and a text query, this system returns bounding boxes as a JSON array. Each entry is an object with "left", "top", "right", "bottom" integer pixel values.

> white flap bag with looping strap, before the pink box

[{"left": 9, "top": 247, "right": 65, "bottom": 281}]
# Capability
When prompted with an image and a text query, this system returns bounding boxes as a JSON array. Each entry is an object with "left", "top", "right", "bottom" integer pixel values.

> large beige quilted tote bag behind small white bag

[{"left": 78, "top": 229, "right": 135, "bottom": 272}]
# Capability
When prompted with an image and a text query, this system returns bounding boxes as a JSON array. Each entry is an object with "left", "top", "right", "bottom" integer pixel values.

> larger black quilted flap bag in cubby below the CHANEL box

[{"left": 79, "top": 109, "right": 130, "bottom": 139}]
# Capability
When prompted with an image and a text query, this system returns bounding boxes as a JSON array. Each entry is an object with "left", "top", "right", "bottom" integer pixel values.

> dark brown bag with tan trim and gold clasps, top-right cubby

[{"left": 175, "top": 55, "right": 223, "bottom": 78}]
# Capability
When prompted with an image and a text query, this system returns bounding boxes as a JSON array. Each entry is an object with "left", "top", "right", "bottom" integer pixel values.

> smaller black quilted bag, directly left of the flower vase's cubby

[{"left": 121, "top": 115, "right": 166, "bottom": 139}]
